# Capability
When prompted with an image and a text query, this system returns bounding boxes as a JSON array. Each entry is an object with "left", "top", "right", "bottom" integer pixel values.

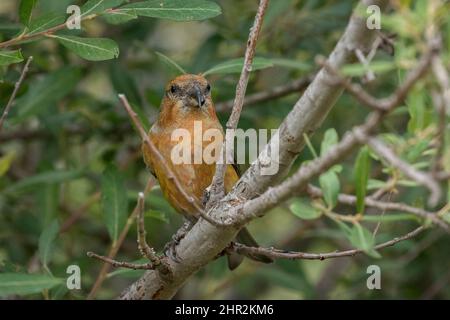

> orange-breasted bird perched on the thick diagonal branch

[{"left": 142, "top": 74, "right": 273, "bottom": 270}]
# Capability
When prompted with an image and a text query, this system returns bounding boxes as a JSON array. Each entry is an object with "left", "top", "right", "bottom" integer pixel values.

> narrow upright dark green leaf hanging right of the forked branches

[{"left": 353, "top": 147, "right": 370, "bottom": 213}]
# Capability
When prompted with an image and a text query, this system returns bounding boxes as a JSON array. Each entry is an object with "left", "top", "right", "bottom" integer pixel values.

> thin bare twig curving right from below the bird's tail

[{"left": 233, "top": 226, "right": 425, "bottom": 260}]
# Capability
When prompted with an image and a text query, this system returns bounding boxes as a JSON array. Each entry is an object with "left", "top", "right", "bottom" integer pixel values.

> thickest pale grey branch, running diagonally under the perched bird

[{"left": 120, "top": 0, "right": 396, "bottom": 299}]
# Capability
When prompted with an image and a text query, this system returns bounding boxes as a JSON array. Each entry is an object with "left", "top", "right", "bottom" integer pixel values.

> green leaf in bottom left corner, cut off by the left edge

[{"left": 0, "top": 273, "right": 63, "bottom": 297}]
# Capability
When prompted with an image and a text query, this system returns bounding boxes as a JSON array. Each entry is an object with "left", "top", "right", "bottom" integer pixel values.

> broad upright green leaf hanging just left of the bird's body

[{"left": 102, "top": 165, "right": 127, "bottom": 241}]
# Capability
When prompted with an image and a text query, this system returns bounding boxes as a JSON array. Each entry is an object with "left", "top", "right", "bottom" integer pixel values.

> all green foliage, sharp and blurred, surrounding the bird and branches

[{"left": 0, "top": 0, "right": 450, "bottom": 299}]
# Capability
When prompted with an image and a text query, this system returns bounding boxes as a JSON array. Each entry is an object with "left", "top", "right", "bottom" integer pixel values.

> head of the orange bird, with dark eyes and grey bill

[{"left": 165, "top": 74, "right": 212, "bottom": 113}]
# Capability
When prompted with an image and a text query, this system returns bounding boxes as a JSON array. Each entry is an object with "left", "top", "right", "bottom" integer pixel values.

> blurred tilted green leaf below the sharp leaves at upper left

[{"left": 14, "top": 67, "right": 81, "bottom": 123}]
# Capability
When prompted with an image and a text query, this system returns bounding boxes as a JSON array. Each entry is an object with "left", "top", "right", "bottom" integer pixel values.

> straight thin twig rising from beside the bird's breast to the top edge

[{"left": 206, "top": 0, "right": 269, "bottom": 210}]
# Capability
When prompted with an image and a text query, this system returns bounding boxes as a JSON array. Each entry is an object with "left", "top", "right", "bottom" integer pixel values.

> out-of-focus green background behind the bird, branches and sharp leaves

[{"left": 0, "top": 0, "right": 450, "bottom": 299}]
